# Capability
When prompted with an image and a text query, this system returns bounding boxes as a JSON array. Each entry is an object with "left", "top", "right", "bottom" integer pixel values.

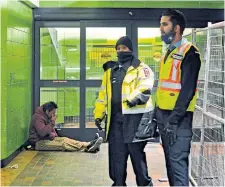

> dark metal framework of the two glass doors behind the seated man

[{"left": 32, "top": 20, "right": 132, "bottom": 141}]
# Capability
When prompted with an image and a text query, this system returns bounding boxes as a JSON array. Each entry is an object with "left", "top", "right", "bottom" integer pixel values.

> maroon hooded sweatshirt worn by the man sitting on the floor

[{"left": 29, "top": 106, "right": 58, "bottom": 143}]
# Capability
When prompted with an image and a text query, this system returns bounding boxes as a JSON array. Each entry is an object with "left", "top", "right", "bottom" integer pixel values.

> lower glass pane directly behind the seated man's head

[{"left": 40, "top": 88, "right": 80, "bottom": 128}]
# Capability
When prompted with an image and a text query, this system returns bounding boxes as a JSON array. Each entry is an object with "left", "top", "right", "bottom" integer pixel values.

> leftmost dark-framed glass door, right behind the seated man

[{"left": 33, "top": 21, "right": 82, "bottom": 139}]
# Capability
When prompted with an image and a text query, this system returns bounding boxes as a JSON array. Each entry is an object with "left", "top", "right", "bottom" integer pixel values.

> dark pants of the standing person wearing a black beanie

[{"left": 109, "top": 116, "right": 152, "bottom": 186}]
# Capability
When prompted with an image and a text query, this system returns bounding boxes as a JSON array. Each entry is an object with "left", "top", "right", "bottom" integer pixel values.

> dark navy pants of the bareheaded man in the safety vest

[{"left": 156, "top": 107, "right": 192, "bottom": 186}]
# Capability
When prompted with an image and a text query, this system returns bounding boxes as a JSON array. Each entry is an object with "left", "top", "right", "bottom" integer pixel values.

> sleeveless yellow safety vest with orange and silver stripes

[{"left": 156, "top": 42, "right": 198, "bottom": 112}]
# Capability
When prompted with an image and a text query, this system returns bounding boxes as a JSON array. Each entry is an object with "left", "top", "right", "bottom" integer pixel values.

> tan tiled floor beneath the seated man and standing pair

[{"left": 1, "top": 143, "right": 168, "bottom": 186}]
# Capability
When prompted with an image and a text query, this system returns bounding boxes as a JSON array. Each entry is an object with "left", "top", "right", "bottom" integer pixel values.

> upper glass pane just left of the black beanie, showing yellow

[{"left": 86, "top": 27, "right": 126, "bottom": 80}]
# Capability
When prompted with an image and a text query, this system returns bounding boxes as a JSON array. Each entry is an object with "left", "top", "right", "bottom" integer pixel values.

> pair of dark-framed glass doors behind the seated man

[{"left": 33, "top": 21, "right": 131, "bottom": 141}]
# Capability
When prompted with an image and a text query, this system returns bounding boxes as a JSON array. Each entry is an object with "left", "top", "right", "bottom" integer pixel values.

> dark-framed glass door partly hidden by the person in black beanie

[{"left": 83, "top": 21, "right": 131, "bottom": 140}]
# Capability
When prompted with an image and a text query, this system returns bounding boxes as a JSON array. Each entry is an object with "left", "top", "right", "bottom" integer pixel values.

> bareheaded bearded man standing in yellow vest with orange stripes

[{"left": 156, "top": 9, "right": 201, "bottom": 186}]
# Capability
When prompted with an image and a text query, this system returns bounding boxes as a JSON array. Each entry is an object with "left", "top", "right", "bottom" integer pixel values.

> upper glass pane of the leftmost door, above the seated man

[{"left": 40, "top": 28, "right": 80, "bottom": 80}]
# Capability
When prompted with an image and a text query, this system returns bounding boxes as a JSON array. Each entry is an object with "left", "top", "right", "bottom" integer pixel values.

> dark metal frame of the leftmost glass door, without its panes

[{"left": 33, "top": 21, "right": 82, "bottom": 139}]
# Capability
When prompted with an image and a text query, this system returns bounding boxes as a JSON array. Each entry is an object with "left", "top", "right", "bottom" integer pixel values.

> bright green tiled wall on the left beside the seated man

[{"left": 0, "top": 0, "right": 32, "bottom": 159}]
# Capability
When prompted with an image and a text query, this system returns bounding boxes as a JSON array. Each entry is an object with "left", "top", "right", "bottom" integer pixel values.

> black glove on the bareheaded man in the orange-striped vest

[{"left": 164, "top": 123, "right": 177, "bottom": 145}]
